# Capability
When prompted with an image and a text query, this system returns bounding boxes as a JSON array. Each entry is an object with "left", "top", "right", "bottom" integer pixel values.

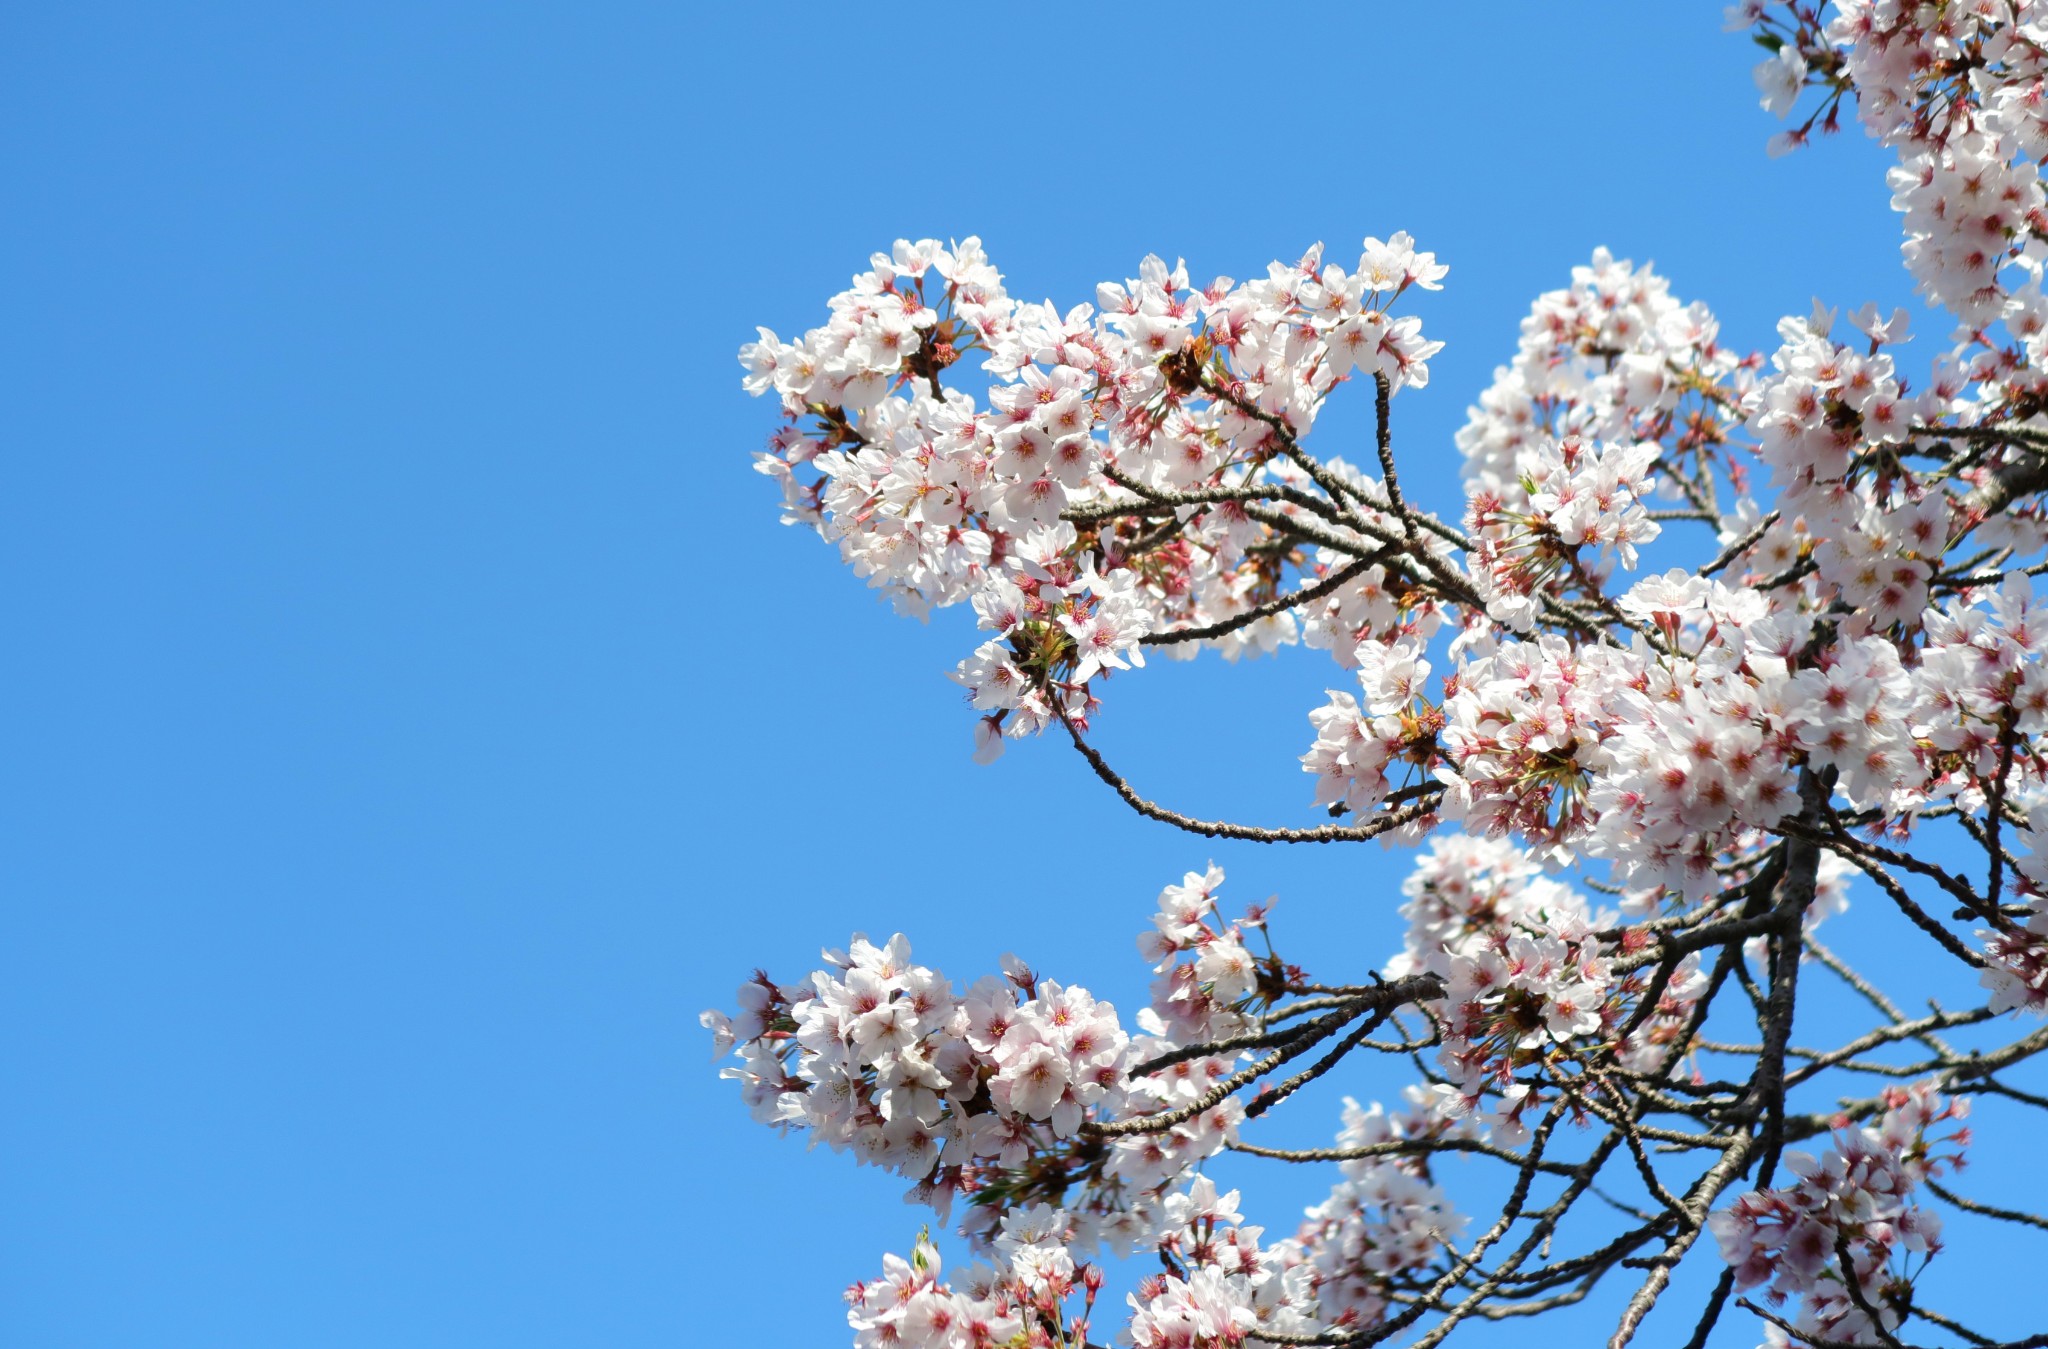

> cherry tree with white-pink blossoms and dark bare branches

[{"left": 705, "top": 0, "right": 2048, "bottom": 1349}]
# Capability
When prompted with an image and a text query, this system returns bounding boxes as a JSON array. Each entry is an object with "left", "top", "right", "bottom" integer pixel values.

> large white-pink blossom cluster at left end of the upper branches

[{"left": 741, "top": 233, "right": 1446, "bottom": 757}]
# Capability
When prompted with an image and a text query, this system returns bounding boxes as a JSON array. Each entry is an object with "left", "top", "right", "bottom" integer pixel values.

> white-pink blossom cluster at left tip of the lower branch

[{"left": 702, "top": 929, "right": 1243, "bottom": 1251}]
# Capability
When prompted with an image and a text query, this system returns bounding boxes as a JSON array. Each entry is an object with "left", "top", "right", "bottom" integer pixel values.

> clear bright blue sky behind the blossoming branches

[{"left": 0, "top": 2, "right": 2021, "bottom": 1349}]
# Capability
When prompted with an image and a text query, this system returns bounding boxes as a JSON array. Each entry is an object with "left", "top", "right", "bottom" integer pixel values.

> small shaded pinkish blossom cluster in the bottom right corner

[{"left": 1708, "top": 1083, "right": 1970, "bottom": 1345}]
